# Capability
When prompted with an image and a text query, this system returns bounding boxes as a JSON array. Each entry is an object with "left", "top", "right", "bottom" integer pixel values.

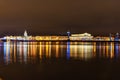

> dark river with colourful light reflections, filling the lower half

[{"left": 0, "top": 41, "right": 120, "bottom": 80}]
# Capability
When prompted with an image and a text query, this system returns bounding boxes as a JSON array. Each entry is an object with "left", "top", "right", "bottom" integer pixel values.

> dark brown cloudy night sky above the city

[{"left": 0, "top": 0, "right": 120, "bottom": 35}]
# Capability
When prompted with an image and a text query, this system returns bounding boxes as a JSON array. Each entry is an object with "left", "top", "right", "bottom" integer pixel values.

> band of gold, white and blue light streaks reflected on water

[{"left": 0, "top": 42, "right": 120, "bottom": 64}]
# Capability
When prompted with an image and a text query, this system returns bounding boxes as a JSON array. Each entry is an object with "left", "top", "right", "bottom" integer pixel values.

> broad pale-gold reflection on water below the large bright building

[{"left": 70, "top": 42, "right": 93, "bottom": 59}]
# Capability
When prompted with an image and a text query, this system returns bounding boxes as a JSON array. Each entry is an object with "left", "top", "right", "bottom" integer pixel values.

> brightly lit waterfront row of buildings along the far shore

[{"left": 0, "top": 30, "right": 116, "bottom": 41}]
